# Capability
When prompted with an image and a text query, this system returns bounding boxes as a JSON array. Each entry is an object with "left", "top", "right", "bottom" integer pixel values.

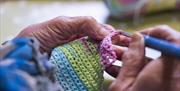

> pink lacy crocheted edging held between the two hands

[{"left": 100, "top": 32, "right": 119, "bottom": 67}]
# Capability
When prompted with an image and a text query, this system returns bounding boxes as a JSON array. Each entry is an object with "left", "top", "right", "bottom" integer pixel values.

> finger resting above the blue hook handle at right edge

[{"left": 141, "top": 25, "right": 180, "bottom": 43}]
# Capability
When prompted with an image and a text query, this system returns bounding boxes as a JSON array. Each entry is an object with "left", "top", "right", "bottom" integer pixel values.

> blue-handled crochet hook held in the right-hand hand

[{"left": 120, "top": 31, "right": 180, "bottom": 58}]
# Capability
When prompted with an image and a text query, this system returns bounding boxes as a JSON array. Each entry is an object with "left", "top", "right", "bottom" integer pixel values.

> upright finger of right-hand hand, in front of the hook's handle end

[{"left": 117, "top": 33, "right": 145, "bottom": 88}]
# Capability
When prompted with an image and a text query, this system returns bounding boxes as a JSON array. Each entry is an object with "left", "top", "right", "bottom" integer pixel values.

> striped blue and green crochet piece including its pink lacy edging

[{"left": 50, "top": 35, "right": 116, "bottom": 91}]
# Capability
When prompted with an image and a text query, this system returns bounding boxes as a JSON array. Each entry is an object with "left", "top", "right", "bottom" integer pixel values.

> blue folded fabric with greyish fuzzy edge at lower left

[{"left": 0, "top": 38, "right": 64, "bottom": 91}]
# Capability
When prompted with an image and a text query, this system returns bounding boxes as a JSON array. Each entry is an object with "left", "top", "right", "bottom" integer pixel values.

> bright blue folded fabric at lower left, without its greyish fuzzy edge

[{"left": 0, "top": 38, "right": 37, "bottom": 91}]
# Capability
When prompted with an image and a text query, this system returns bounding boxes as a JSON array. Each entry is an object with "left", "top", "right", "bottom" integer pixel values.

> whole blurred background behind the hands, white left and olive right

[{"left": 0, "top": 0, "right": 180, "bottom": 88}]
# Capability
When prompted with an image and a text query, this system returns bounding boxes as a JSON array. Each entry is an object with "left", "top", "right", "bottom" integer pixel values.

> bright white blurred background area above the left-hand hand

[{"left": 0, "top": 0, "right": 108, "bottom": 43}]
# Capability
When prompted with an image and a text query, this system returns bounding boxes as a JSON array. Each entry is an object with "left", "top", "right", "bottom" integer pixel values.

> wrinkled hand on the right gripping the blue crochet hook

[{"left": 109, "top": 25, "right": 180, "bottom": 91}]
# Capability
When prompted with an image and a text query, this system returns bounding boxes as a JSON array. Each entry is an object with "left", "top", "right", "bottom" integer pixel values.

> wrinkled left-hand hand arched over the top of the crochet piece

[{"left": 17, "top": 16, "right": 113, "bottom": 53}]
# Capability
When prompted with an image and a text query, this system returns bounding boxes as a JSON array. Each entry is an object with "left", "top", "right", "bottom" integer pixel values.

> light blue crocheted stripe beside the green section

[{"left": 50, "top": 48, "right": 87, "bottom": 91}]
